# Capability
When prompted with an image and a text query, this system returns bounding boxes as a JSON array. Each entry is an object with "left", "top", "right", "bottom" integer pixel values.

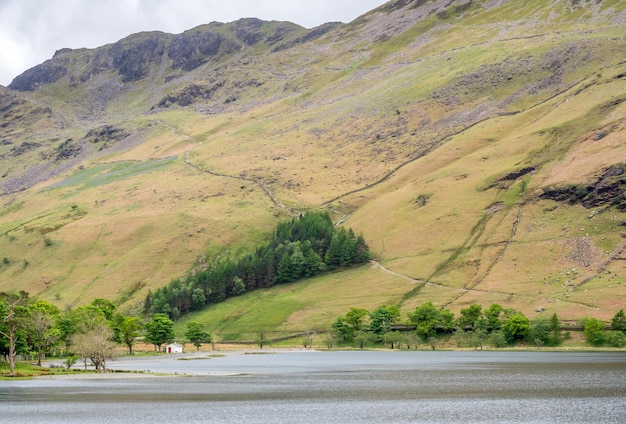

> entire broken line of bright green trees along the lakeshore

[{"left": 0, "top": 292, "right": 626, "bottom": 376}]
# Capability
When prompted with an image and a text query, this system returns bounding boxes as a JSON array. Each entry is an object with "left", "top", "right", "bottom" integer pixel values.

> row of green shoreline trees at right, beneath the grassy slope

[{"left": 329, "top": 302, "right": 626, "bottom": 350}]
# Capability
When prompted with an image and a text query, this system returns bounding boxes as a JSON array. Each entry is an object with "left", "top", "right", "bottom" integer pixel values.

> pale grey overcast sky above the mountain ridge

[{"left": 0, "top": 0, "right": 386, "bottom": 86}]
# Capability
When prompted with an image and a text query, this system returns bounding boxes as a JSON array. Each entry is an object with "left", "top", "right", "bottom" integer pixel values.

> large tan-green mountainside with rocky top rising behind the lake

[{"left": 0, "top": 0, "right": 626, "bottom": 329}]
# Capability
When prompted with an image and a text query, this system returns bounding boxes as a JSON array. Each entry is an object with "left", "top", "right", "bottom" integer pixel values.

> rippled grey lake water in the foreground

[{"left": 0, "top": 351, "right": 626, "bottom": 424}]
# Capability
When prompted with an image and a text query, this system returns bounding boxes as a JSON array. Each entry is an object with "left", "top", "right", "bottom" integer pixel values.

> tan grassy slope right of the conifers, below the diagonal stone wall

[{"left": 348, "top": 70, "right": 626, "bottom": 318}]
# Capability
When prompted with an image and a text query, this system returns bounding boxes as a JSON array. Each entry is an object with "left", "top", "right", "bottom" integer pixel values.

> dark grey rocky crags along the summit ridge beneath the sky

[{"left": 8, "top": 19, "right": 312, "bottom": 91}]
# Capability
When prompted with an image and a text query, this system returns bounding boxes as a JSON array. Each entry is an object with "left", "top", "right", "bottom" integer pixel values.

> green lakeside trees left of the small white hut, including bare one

[{"left": 0, "top": 291, "right": 212, "bottom": 376}]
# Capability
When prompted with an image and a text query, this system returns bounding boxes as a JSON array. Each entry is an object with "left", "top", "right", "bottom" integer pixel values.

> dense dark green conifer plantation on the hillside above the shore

[{"left": 145, "top": 212, "right": 369, "bottom": 320}]
